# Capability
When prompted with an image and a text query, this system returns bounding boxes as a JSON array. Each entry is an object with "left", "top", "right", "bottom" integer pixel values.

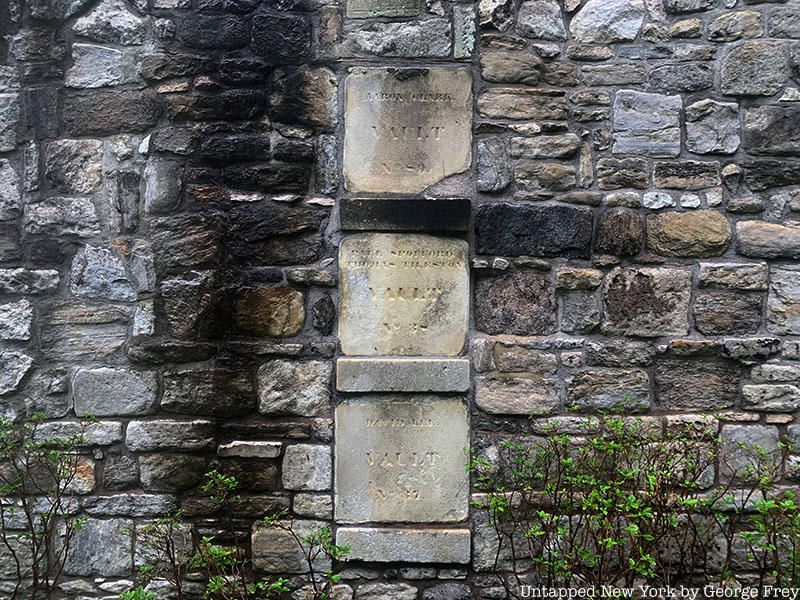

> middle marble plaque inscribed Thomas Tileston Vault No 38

[{"left": 339, "top": 233, "right": 469, "bottom": 356}]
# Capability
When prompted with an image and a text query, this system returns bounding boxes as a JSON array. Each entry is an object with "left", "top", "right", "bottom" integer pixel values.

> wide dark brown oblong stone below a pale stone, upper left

[{"left": 61, "top": 90, "right": 164, "bottom": 135}]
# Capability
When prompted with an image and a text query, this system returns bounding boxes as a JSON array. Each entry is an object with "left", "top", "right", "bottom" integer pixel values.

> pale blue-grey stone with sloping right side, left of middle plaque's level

[{"left": 70, "top": 246, "right": 136, "bottom": 302}]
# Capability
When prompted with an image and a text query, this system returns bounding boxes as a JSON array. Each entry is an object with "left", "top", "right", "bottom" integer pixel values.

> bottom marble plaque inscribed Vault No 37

[{"left": 335, "top": 395, "right": 469, "bottom": 523}]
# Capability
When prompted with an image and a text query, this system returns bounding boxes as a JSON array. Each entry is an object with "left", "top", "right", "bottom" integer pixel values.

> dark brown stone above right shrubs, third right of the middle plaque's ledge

[{"left": 655, "top": 358, "right": 741, "bottom": 411}]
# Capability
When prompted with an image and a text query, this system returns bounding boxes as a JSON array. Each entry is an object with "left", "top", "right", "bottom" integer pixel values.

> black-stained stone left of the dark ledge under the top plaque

[{"left": 228, "top": 201, "right": 328, "bottom": 265}]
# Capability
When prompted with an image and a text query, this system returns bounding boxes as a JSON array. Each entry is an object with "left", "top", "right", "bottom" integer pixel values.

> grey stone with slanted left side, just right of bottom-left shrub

[{"left": 64, "top": 519, "right": 133, "bottom": 577}]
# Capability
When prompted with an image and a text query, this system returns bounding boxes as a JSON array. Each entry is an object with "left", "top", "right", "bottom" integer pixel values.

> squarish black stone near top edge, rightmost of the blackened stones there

[{"left": 252, "top": 15, "right": 311, "bottom": 63}]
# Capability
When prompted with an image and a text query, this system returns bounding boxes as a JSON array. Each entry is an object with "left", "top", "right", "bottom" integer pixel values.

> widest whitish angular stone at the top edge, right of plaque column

[{"left": 569, "top": 0, "right": 647, "bottom": 44}]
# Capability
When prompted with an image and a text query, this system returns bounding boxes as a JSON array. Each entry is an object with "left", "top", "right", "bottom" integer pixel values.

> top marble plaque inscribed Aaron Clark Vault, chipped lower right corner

[{"left": 344, "top": 67, "right": 472, "bottom": 193}]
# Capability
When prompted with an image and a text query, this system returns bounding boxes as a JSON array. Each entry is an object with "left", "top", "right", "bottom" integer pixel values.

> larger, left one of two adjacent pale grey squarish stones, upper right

[{"left": 613, "top": 90, "right": 682, "bottom": 157}]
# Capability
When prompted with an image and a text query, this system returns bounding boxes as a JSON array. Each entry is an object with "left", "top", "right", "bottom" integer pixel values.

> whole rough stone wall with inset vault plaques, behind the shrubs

[{"left": 0, "top": 0, "right": 800, "bottom": 600}]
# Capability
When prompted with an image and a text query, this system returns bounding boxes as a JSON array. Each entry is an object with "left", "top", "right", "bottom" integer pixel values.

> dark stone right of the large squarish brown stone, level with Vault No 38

[{"left": 694, "top": 290, "right": 762, "bottom": 335}]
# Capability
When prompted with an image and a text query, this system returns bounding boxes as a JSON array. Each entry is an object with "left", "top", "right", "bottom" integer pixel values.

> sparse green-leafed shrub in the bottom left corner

[{"left": 0, "top": 414, "right": 85, "bottom": 600}]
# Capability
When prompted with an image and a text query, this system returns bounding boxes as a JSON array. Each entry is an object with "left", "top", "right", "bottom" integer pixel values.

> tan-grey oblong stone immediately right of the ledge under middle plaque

[{"left": 475, "top": 372, "right": 561, "bottom": 416}]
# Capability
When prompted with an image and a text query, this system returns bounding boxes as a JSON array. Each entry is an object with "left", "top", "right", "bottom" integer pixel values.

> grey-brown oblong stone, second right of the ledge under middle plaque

[{"left": 567, "top": 369, "right": 651, "bottom": 413}]
